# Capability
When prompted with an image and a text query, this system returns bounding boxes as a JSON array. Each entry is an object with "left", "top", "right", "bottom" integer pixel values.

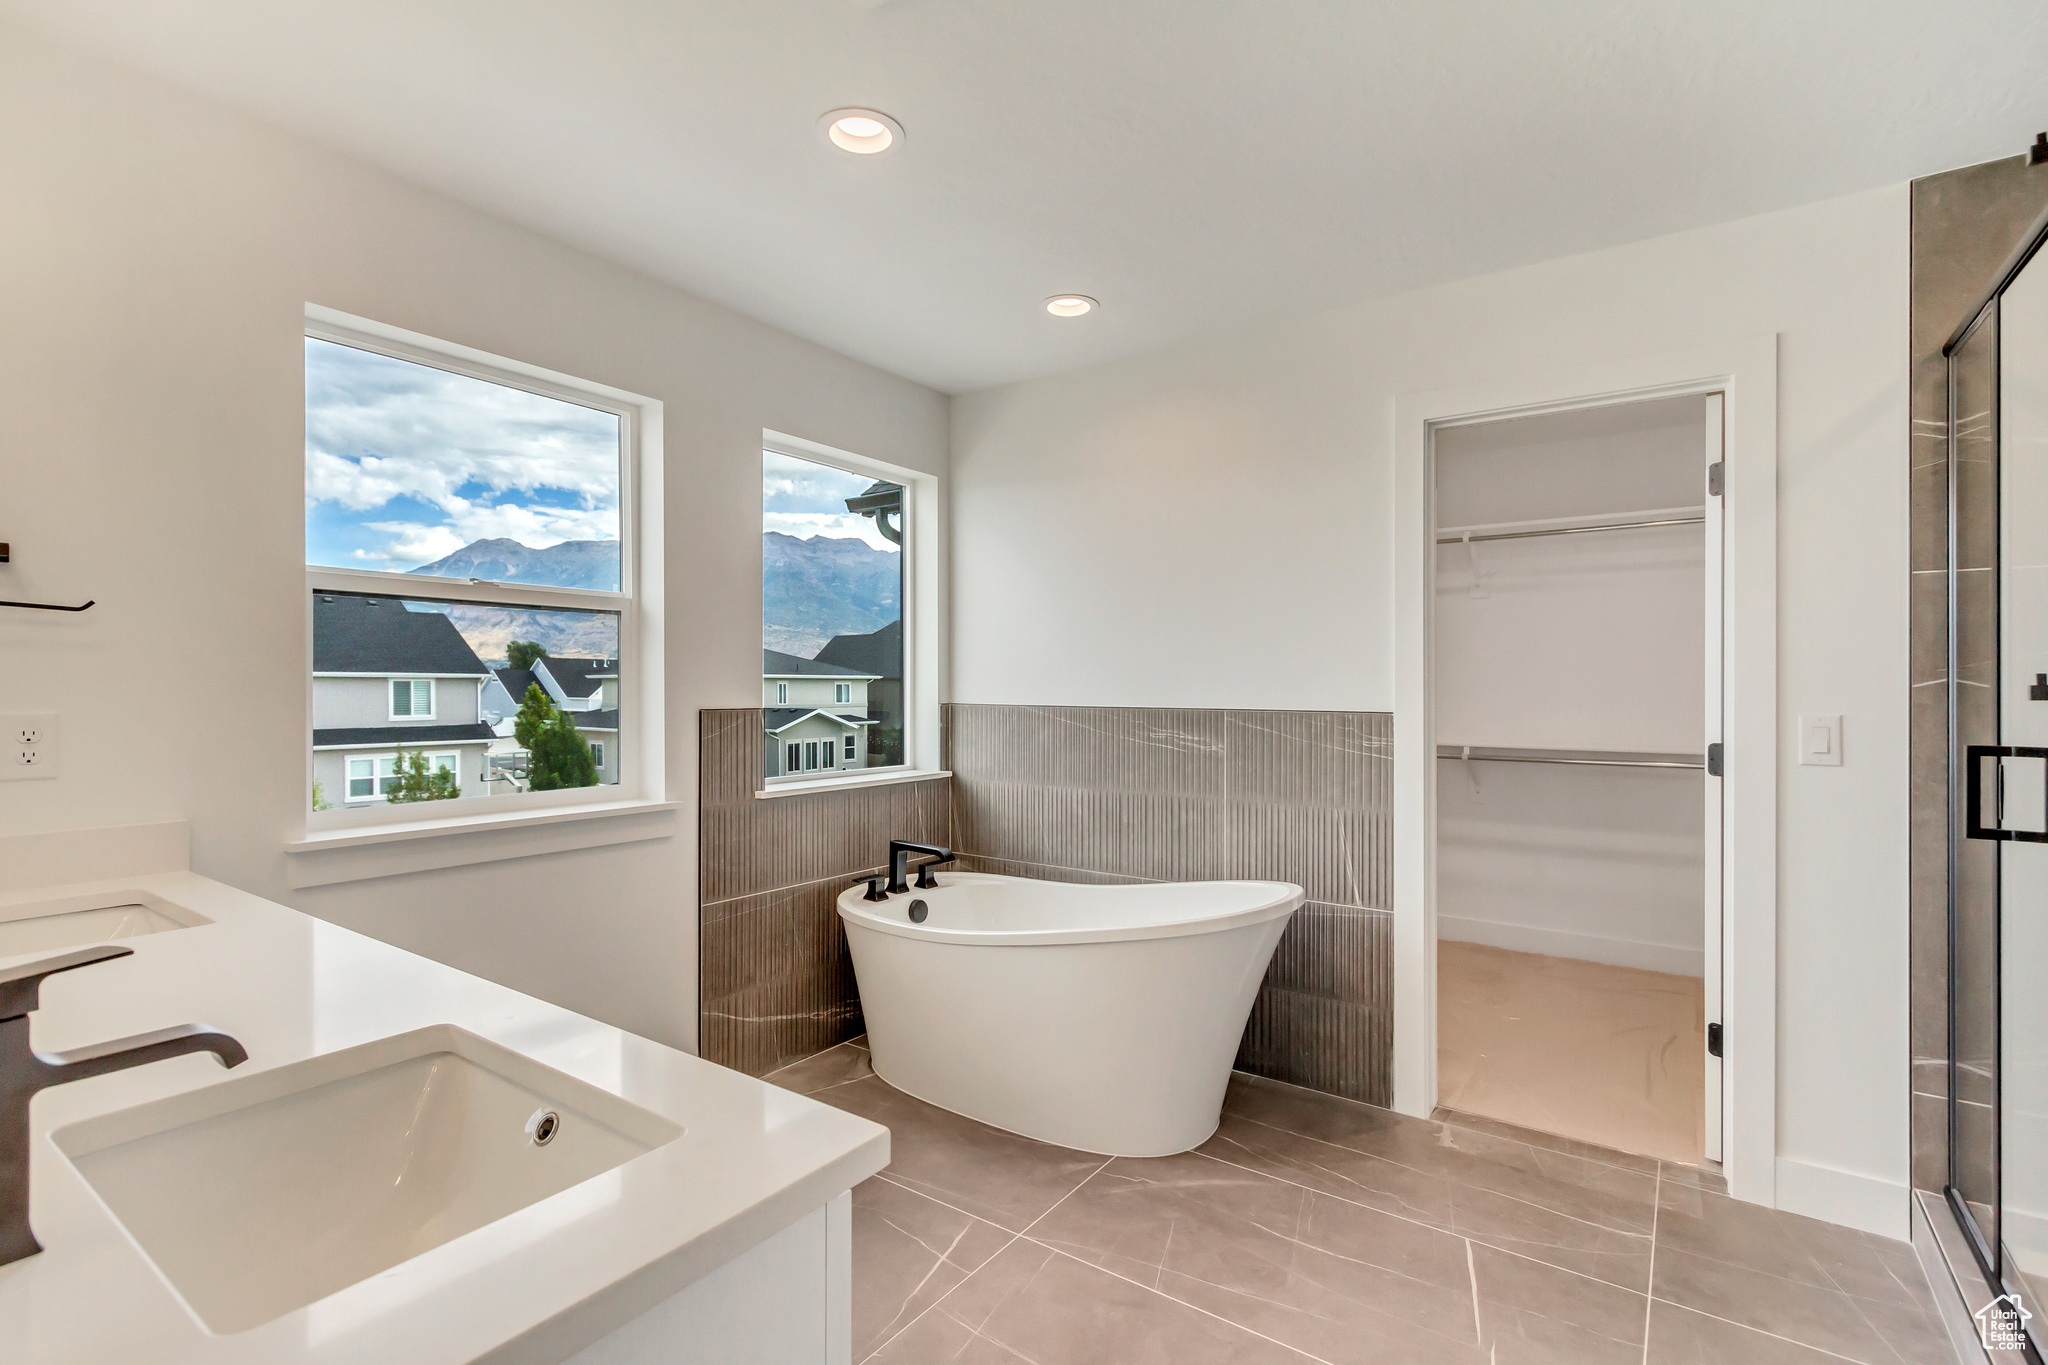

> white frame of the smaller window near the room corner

[{"left": 762, "top": 430, "right": 944, "bottom": 794}]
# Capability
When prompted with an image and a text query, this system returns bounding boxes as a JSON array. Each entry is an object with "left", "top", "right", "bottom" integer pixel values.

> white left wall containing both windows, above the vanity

[{"left": 0, "top": 31, "right": 946, "bottom": 1046}]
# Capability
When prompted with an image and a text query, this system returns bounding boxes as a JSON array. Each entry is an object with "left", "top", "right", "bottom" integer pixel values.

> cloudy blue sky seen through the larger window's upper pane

[{"left": 305, "top": 347, "right": 618, "bottom": 571}]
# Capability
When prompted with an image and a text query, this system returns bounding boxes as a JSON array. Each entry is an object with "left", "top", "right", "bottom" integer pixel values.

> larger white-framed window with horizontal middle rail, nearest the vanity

[{"left": 305, "top": 309, "right": 662, "bottom": 831}]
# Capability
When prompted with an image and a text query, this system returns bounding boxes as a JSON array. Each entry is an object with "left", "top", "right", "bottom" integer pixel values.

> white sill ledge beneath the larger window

[{"left": 285, "top": 800, "right": 680, "bottom": 886}]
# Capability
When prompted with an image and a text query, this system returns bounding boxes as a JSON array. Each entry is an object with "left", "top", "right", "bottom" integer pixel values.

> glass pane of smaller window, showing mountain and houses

[{"left": 762, "top": 450, "right": 907, "bottom": 782}]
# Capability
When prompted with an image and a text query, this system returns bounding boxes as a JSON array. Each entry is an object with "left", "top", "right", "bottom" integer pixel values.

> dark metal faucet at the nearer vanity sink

[{"left": 0, "top": 943, "right": 250, "bottom": 1265}]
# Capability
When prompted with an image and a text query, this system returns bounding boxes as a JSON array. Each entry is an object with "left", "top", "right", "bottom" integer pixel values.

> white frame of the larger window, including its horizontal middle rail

[{"left": 301, "top": 305, "right": 668, "bottom": 851}]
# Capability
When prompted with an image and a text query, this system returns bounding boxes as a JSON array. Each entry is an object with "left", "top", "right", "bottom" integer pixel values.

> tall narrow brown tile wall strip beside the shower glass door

[{"left": 1911, "top": 156, "right": 2048, "bottom": 1189}]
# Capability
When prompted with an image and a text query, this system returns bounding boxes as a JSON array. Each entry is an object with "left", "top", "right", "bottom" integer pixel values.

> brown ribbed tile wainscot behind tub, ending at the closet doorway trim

[{"left": 944, "top": 704, "right": 1393, "bottom": 1105}]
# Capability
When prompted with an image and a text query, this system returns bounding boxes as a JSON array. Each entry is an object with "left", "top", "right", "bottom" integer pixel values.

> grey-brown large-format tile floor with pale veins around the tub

[{"left": 770, "top": 1042, "right": 1950, "bottom": 1365}]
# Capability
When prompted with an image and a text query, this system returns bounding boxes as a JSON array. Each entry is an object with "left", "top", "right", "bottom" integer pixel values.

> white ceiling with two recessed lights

[{"left": 0, "top": 0, "right": 2048, "bottom": 391}]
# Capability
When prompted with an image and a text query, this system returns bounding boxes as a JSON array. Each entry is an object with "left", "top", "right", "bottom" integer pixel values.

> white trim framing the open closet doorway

[{"left": 1393, "top": 334, "right": 1778, "bottom": 1205}]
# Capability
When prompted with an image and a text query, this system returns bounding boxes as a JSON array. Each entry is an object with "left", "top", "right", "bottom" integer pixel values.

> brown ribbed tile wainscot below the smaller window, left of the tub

[{"left": 696, "top": 710, "right": 950, "bottom": 1076}]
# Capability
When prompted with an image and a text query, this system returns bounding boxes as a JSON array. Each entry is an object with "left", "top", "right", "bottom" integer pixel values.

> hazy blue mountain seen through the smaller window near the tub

[{"left": 762, "top": 530, "right": 903, "bottom": 659}]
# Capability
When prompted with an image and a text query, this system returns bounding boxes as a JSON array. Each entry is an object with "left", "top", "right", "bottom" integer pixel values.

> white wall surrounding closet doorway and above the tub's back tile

[{"left": 952, "top": 184, "right": 1909, "bottom": 1236}]
